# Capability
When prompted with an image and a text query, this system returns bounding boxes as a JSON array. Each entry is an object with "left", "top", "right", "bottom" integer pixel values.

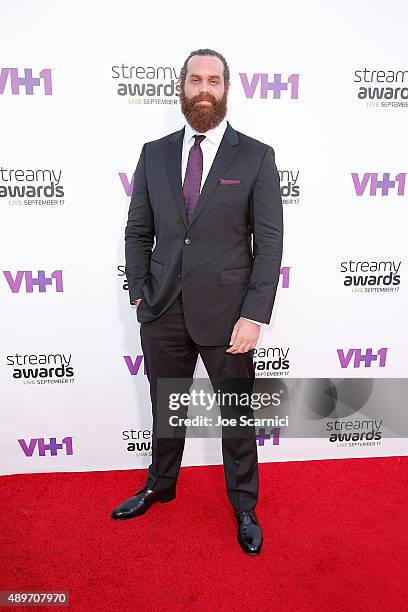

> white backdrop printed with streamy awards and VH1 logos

[{"left": 0, "top": 0, "right": 408, "bottom": 474}]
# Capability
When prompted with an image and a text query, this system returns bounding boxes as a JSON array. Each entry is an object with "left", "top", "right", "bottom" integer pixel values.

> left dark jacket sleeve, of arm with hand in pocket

[{"left": 125, "top": 143, "right": 154, "bottom": 303}]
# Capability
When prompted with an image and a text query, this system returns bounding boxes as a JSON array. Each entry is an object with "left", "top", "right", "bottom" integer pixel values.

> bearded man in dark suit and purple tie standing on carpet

[{"left": 112, "top": 49, "right": 283, "bottom": 554}]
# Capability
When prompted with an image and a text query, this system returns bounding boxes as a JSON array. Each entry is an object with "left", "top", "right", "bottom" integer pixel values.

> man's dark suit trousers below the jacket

[{"left": 140, "top": 293, "right": 258, "bottom": 510}]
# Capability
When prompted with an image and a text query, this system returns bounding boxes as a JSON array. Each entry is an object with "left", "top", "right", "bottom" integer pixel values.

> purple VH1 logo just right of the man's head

[{"left": 239, "top": 72, "right": 299, "bottom": 100}]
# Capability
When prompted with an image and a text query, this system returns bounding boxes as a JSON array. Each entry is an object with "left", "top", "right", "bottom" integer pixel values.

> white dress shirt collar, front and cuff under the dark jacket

[{"left": 181, "top": 118, "right": 262, "bottom": 325}]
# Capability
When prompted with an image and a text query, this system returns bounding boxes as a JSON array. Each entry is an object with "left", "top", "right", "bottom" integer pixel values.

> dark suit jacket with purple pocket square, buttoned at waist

[{"left": 125, "top": 122, "right": 283, "bottom": 346}]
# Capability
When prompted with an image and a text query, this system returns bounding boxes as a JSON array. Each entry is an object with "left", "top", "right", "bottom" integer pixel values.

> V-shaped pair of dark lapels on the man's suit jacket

[{"left": 166, "top": 122, "right": 239, "bottom": 228}]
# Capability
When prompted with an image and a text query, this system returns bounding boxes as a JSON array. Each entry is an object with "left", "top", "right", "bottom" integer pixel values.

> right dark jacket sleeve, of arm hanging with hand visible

[{"left": 241, "top": 147, "right": 283, "bottom": 323}]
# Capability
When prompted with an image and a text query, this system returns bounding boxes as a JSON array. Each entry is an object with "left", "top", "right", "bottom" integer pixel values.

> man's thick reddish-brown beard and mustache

[{"left": 180, "top": 87, "right": 228, "bottom": 133}]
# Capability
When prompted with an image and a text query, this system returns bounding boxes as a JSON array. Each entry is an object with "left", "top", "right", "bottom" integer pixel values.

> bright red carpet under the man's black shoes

[{"left": 0, "top": 457, "right": 408, "bottom": 612}]
